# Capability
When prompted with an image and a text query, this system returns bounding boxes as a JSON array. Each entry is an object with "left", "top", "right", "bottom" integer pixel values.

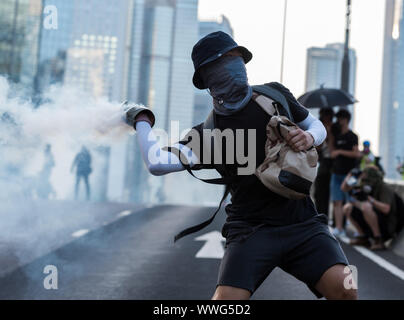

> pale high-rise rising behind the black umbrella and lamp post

[{"left": 305, "top": 43, "right": 356, "bottom": 119}]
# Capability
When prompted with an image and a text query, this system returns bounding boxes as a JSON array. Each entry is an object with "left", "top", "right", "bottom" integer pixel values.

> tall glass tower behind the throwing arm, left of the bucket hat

[{"left": 125, "top": 0, "right": 198, "bottom": 202}]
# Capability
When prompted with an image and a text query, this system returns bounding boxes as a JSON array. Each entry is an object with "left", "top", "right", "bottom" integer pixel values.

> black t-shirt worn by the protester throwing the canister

[{"left": 180, "top": 99, "right": 317, "bottom": 237}]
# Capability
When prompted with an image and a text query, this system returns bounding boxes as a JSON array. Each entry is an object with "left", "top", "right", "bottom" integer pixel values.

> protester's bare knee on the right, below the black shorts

[{"left": 315, "top": 264, "right": 358, "bottom": 300}]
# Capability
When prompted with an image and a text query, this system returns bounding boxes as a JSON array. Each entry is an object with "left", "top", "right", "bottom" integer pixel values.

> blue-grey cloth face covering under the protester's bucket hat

[{"left": 201, "top": 56, "right": 252, "bottom": 115}]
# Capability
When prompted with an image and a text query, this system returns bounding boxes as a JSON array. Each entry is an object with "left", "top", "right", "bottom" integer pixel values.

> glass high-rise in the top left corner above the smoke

[{"left": 0, "top": 0, "right": 42, "bottom": 90}]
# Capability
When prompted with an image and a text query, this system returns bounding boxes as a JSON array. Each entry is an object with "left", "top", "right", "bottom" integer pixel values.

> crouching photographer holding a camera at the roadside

[{"left": 341, "top": 165, "right": 397, "bottom": 250}]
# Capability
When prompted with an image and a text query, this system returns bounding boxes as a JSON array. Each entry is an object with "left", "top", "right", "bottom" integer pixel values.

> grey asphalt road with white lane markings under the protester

[{"left": 0, "top": 204, "right": 404, "bottom": 300}]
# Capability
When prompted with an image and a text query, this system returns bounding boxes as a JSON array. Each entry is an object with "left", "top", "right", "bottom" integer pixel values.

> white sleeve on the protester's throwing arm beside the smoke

[{"left": 136, "top": 121, "right": 198, "bottom": 176}]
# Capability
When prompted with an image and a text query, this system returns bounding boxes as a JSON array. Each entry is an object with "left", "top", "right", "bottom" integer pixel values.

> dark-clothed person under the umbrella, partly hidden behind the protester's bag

[{"left": 314, "top": 108, "right": 334, "bottom": 216}]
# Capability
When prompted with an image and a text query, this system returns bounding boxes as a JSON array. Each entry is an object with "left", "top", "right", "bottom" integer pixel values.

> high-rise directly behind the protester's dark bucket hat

[{"left": 193, "top": 15, "right": 233, "bottom": 124}]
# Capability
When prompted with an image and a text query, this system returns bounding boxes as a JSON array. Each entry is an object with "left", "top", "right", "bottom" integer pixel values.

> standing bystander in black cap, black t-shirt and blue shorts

[{"left": 330, "top": 109, "right": 362, "bottom": 237}]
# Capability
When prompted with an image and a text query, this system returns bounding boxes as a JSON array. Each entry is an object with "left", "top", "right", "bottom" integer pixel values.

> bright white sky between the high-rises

[{"left": 198, "top": 0, "right": 385, "bottom": 154}]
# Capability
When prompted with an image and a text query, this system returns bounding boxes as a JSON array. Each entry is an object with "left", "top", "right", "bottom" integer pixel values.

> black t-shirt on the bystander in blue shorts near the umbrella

[{"left": 333, "top": 130, "right": 358, "bottom": 174}]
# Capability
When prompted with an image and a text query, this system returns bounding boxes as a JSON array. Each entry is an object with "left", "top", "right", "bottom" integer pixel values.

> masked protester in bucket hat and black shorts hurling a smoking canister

[{"left": 133, "top": 32, "right": 356, "bottom": 299}]
